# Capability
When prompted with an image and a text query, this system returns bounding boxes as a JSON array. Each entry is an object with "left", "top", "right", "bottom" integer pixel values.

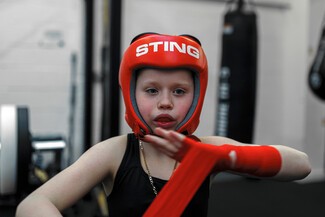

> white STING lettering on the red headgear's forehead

[{"left": 136, "top": 41, "right": 200, "bottom": 59}]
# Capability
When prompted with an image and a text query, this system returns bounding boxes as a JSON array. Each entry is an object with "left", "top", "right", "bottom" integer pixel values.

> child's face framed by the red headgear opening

[{"left": 135, "top": 69, "right": 194, "bottom": 130}]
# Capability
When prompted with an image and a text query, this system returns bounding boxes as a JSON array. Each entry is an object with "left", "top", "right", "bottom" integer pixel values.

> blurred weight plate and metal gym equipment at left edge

[{"left": 0, "top": 105, "right": 66, "bottom": 205}]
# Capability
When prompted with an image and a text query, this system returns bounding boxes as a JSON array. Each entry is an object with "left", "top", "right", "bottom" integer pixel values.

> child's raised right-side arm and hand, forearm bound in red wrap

[{"left": 145, "top": 128, "right": 311, "bottom": 181}]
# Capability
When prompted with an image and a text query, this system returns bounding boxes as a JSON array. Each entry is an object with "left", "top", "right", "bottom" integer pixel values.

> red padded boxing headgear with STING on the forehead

[{"left": 119, "top": 33, "right": 208, "bottom": 137}]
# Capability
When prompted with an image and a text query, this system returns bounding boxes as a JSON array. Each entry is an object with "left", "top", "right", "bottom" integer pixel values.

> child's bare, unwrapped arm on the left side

[{"left": 16, "top": 136, "right": 126, "bottom": 217}]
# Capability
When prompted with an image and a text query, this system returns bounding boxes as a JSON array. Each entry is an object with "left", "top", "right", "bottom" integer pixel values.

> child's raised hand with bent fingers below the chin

[{"left": 144, "top": 128, "right": 189, "bottom": 162}]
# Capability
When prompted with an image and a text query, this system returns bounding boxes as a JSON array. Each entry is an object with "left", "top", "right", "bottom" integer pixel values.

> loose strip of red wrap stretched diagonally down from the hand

[{"left": 143, "top": 139, "right": 217, "bottom": 217}]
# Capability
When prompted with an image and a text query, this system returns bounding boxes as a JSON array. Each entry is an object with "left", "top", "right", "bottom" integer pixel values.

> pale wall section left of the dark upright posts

[{"left": 0, "top": 0, "right": 84, "bottom": 163}]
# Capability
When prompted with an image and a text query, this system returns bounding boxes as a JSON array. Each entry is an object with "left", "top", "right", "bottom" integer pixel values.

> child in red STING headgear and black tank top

[{"left": 16, "top": 33, "right": 310, "bottom": 217}]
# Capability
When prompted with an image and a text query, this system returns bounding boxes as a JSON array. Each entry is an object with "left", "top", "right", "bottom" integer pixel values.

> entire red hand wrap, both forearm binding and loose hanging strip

[{"left": 144, "top": 138, "right": 281, "bottom": 217}]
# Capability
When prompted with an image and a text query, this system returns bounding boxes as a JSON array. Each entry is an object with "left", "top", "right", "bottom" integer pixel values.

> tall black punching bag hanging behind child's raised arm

[{"left": 215, "top": 1, "right": 257, "bottom": 143}]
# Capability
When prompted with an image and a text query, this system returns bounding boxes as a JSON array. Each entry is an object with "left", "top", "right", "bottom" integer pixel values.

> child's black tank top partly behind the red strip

[{"left": 107, "top": 134, "right": 210, "bottom": 217}]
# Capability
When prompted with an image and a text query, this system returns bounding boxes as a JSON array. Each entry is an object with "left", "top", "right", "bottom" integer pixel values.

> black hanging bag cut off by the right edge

[{"left": 308, "top": 17, "right": 325, "bottom": 100}]
